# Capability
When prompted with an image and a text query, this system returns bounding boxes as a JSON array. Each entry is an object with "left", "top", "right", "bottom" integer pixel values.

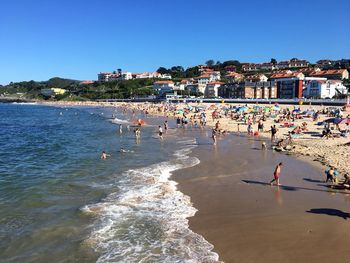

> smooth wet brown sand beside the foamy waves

[{"left": 174, "top": 134, "right": 350, "bottom": 263}]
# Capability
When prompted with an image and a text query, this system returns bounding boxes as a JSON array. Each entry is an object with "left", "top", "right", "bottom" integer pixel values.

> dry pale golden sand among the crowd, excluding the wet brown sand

[{"left": 41, "top": 102, "right": 350, "bottom": 174}]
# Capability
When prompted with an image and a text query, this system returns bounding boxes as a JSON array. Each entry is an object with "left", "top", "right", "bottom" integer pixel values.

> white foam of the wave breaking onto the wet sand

[{"left": 82, "top": 141, "right": 218, "bottom": 263}]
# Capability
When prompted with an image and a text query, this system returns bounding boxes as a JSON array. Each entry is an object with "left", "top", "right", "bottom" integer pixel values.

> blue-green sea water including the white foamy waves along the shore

[{"left": 0, "top": 104, "right": 218, "bottom": 262}]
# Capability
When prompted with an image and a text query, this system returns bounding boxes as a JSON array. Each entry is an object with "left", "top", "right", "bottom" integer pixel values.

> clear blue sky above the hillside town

[{"left": 0, "top": 0, "right": 350, "bottom": 84}]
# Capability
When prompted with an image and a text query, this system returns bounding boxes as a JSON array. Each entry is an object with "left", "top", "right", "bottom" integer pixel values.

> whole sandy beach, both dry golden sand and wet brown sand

[{"left": 39, "top": 100, "right": 350, "bottom": 262}]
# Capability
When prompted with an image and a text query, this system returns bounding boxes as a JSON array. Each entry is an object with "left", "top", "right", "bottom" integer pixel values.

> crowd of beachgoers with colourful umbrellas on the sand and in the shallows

[{"left": 101, "top": 100, "right": 350, "bottom": 189}]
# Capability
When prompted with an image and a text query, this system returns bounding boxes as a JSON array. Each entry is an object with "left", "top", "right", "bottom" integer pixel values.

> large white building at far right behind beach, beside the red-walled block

[{"left": 304, "top": 79, "right": 347, "bottom": 99}]
